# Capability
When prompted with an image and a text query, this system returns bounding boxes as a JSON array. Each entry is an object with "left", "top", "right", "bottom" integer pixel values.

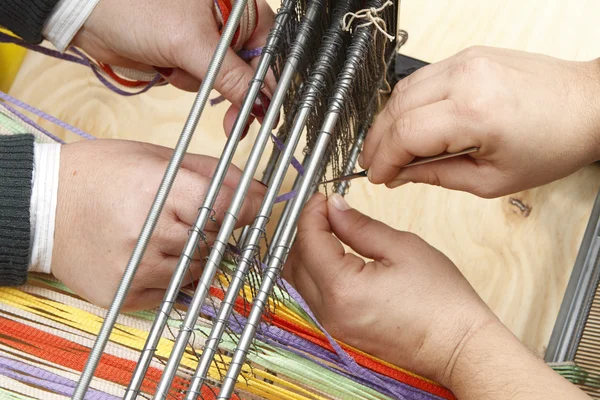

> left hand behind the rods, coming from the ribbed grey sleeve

[{"left": 52, "top": 140, "right": 265, "bottom": 310}]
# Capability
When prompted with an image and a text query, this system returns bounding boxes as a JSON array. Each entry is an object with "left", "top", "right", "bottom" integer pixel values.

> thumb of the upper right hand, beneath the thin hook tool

[{"left": 386, "top": 156, "right": 489, "bottom": 195}]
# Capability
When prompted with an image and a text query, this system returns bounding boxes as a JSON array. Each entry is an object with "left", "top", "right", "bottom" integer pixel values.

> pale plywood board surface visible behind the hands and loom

[{"left": 11, "top": 0, "right": 600, "bottom": 352}]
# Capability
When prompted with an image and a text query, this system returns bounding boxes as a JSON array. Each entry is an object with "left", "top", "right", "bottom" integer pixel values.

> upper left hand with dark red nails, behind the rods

[{"left": 74, "top": 0, "right": 274, "bottom": 134}]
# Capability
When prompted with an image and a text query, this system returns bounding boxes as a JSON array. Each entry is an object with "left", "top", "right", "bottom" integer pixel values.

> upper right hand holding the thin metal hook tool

[{"left": 359, "top": 47, "right": 600, "bottom": 197}]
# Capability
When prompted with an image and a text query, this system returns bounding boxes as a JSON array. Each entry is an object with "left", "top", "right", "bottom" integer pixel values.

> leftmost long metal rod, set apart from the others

[{"left": 73, "top": 0, "right": 248, "bottom": 400}]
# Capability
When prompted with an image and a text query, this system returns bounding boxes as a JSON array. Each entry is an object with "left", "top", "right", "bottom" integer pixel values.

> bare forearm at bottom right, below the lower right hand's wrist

[{"left": 446, "top": 322, "right": 589, "bottom": 400}]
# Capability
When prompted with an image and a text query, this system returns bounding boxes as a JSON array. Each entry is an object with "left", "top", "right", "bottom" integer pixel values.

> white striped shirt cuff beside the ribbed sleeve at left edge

[{"left": 29, "top": 143, "right": 60, "bottom": 274}]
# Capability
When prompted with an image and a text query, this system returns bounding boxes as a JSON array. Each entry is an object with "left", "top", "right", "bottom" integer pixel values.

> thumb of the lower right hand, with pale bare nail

[{"left": 327, "top": 193, "right": 401, "bottom": 261}]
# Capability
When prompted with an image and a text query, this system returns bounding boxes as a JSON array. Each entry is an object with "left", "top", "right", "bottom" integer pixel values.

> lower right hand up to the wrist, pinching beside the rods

[{"left": 283, "top": 194, "right": 496, "bottom": 383}]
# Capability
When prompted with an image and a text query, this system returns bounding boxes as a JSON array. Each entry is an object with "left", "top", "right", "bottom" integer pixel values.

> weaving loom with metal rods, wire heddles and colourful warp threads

[{"left": 0, "top": 0, "right": 462, "bottom": 399}]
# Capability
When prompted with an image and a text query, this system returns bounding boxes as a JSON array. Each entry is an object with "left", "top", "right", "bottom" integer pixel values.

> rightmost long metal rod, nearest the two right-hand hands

[{"left": 217, "top": 10, "right": 372, "bottom": 399}]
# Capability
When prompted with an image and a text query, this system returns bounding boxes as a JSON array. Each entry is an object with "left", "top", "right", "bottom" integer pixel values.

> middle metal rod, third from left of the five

[{"left": 155, "top": 1, "right": 323, "bottom": 398}]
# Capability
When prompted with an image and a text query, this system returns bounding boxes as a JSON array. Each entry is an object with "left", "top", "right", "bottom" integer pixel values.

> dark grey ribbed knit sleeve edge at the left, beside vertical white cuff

[{"left": 0, "top": 135, "right": 34, "bottom": 286}]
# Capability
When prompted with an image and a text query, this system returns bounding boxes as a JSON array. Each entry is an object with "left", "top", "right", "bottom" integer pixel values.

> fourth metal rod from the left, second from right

[{"left": 186, "top": 0, "right": 354, "bottom": 390}]
